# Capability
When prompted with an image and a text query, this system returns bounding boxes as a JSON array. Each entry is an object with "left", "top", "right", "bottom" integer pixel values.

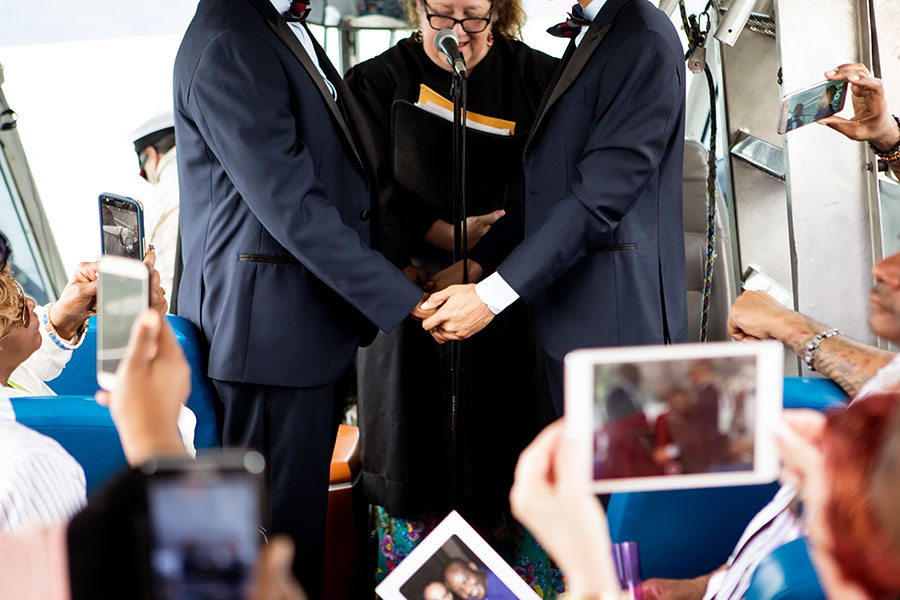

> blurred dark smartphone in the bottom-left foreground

[{"left": 142, "top": 450, "right": 265, "bottom": 600}]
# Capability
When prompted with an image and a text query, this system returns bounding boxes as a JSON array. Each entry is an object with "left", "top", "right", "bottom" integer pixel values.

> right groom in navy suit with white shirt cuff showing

[{"left": 422, "top": 0, "right": 687, "bottom": 414}]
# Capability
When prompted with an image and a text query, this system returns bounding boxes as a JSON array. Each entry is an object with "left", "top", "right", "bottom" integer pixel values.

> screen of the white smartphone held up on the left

[{"left": 97, "top": 270, "right": 150, "bottom": 373}]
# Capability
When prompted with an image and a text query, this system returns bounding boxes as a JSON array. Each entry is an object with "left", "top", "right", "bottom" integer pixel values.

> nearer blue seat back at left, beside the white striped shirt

[{"left": 11, "top": 396, "right": 127, "bottom": 493}]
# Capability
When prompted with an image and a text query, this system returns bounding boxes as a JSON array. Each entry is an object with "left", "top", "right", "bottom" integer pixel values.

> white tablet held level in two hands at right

[{"left": 565, "top": 341, "right": 784, "bottom": 493}]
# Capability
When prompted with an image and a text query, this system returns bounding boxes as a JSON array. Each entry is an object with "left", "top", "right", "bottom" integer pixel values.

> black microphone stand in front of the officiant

[{"left": 450, "top": 69, "right": 469, "bottom": 509}]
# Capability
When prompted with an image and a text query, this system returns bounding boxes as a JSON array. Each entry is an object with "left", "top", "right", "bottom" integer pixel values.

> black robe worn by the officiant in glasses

[{"left": 345, "top": 37, "right": 558, "bottom": 518}]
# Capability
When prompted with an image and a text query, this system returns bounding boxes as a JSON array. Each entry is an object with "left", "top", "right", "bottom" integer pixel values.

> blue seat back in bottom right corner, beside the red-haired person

[{"left": 746, "top": 538, "right": 825, "bottom": 600}]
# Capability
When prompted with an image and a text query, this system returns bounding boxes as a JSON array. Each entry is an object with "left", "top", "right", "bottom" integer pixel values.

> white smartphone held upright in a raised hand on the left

[{"left": 97, "top": 255, "right": 150, "bottom": 390}]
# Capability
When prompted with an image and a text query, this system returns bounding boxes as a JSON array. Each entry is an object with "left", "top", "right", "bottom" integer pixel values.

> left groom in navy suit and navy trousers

[{"left": 174, "top": 0, "right": 422, "bottom": 598}]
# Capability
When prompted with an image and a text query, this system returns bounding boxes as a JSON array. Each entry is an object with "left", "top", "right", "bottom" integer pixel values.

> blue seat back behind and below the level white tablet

[{"left": 607, "top": 377, "right": 847, "bottom": 579}]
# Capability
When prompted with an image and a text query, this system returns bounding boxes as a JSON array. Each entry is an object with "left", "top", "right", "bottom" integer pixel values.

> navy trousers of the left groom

[{"left": 213, "top": 380, "right": 341, "bottom": 600}]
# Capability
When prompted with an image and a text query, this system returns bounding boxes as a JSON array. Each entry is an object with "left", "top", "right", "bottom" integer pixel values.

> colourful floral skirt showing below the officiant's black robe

[{"left": 375, "top": 506, "right": 565, "bottom": 600}]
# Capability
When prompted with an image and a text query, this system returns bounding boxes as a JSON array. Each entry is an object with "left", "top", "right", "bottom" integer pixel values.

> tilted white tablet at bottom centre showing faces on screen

[{"left": 375, "top": 511, "right": 538, "bottom": 600}]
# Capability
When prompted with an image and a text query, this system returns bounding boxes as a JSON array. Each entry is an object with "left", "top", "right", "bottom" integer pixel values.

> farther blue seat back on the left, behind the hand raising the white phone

[{"left": 49, "top": 315, "right": 220, "bottom": 449}]
